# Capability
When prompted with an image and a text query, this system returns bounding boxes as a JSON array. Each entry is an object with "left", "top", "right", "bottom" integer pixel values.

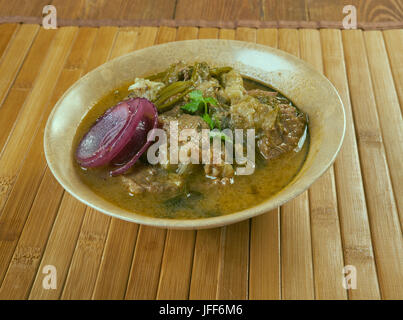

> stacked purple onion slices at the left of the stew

[{"left": 76, "top": 98, "right": 158, "bottom": 176}]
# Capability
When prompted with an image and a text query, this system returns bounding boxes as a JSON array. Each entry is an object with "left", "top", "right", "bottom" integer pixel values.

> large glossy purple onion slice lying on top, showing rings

[{"left": 76, "top": 98, "right": 156, "bottom": 167}]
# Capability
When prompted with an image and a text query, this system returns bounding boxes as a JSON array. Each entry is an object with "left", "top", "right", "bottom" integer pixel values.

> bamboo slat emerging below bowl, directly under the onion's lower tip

[{"left": 93, "top": 28, "right": 157, "bottom": 299}]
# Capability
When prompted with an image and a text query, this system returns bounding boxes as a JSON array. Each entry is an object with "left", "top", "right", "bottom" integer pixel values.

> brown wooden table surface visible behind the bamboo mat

[{"left": 0, "top": 0, "right": 403, "bottom": 26}]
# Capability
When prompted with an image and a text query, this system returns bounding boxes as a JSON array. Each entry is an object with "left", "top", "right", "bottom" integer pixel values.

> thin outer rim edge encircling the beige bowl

[{"left": 43, "top": 39, "right": 346, "bottom": 230}]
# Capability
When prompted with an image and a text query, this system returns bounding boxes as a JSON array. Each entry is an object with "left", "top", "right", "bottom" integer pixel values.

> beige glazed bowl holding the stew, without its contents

[{"left": 44, "top": 40, "right": 345, "bottom": 229}]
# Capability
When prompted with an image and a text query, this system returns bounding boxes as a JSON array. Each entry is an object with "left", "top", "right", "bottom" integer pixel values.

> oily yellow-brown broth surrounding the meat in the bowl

[{"left": 73, "top": 79, "right": 309, "bottom": 219}]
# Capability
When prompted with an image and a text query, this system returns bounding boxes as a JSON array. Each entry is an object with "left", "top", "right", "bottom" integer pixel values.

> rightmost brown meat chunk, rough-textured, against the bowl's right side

[{"left": 257, "top": 104, "right": 307, "bottom": 159}]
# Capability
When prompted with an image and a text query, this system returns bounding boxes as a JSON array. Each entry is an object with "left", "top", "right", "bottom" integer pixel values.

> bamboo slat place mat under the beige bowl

[{"left": 0, "top": 24, "right": 403, "bottom": 299}]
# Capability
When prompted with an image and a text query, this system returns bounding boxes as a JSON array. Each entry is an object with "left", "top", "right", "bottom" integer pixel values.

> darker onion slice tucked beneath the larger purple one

[{"left": 110, "top": 98, "right": 158, "bottom": 176}]
